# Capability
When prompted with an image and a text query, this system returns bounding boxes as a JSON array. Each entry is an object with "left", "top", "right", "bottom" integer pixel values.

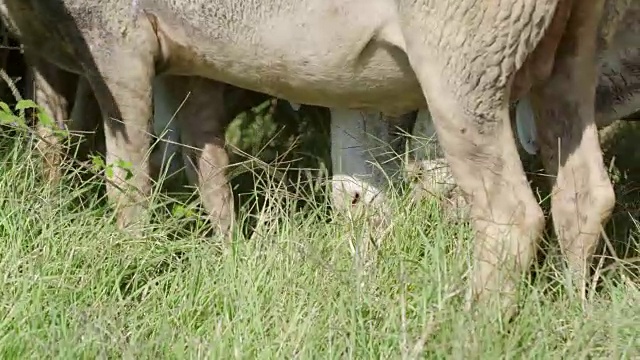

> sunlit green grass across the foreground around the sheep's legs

[{"left": 0, "top": 106, "right": 640, "bottom": 359}]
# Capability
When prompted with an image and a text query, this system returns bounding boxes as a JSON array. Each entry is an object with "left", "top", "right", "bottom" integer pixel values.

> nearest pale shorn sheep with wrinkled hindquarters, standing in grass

[{"left": 0, "top": 0, "right": 614, "bottom": 314}]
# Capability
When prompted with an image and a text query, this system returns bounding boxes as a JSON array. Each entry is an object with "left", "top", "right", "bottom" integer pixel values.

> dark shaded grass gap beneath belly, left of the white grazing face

[{"left": 222, "top": 101, "right": 331, "bottom": 236}]
